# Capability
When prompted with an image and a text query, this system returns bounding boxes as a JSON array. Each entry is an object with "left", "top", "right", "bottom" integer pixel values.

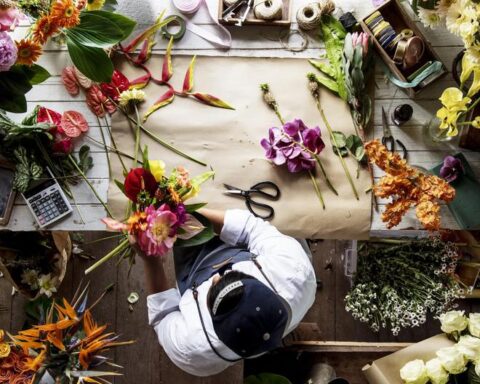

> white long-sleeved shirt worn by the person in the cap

[{"left": 147, "top": 209, "right": 317, "bottom": 376}]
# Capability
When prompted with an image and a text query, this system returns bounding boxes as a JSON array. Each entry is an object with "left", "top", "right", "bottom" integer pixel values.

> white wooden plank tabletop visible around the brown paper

[{"left": 3, "top": 0, "right": 480, "bottom": 234}]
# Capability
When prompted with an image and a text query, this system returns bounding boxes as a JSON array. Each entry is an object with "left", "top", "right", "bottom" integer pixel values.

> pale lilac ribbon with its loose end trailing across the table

[{"left": 173, "top": 0, "right": 232, "bottom": 48}]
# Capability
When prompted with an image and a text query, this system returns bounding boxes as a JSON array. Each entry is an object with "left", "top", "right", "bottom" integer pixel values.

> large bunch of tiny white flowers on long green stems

[{"left": 345, "top": 237, "right": 463, "bottom": 335}]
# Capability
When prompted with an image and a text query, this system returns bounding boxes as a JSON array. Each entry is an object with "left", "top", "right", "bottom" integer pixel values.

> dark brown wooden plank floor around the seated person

[{"left": 0, "top": 232, "right": 480, "bottom": 384}]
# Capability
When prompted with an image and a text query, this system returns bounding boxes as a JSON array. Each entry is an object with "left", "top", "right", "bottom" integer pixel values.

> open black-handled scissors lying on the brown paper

[{"left": 223, "top": 181, "right": 280, "bottom": 220}]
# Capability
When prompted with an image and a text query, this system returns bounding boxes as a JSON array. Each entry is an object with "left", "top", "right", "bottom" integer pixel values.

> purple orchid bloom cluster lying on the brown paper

[{"left": 260, "top": 119, "right": 325, "bottom": 173}]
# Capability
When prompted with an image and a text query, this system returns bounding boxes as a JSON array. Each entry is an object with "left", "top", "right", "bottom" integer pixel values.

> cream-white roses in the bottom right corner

[{"left": 400, "top": 311, "right": 480, "bottom": 384}]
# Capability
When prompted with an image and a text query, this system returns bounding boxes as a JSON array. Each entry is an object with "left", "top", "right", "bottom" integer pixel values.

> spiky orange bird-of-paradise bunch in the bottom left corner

[{"left": 0, "top": 288, "right": 133, "bottom": 384}]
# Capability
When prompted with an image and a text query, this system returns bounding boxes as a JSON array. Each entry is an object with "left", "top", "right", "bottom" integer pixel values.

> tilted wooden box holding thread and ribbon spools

[{"left": 360, "top": 0, "right": 447, "bottom": 98}]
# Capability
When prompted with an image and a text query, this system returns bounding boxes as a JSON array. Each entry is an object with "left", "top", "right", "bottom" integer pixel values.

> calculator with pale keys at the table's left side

[{"left": 22, "top": 168, "right": 73, "bottom": 228}]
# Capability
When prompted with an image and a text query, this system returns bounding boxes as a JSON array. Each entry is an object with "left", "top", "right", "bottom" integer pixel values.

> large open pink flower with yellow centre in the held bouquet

[{"left": 137, "top": 204, "right": 177, "bottom": 256}]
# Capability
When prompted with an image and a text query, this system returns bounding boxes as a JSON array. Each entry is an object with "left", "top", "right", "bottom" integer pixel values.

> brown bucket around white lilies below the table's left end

[{"left": 0, "top": 231, "right": 72, "bottom": 300}]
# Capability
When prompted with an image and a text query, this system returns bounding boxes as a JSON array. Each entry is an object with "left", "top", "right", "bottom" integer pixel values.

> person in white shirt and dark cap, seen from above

[{"left": 133, "top": 209, "right": 317, "bottom": 376}]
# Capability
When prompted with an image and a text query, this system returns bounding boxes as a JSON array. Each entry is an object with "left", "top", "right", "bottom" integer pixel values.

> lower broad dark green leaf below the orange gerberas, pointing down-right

[{"left": 67, "top": 36, "right": 114, "bottom": 83}]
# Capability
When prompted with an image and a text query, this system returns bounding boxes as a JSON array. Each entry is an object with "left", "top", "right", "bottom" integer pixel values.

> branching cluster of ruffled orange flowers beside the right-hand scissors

[{"left": 365, "top": 140, "right": 455, "bottom": 231}]
